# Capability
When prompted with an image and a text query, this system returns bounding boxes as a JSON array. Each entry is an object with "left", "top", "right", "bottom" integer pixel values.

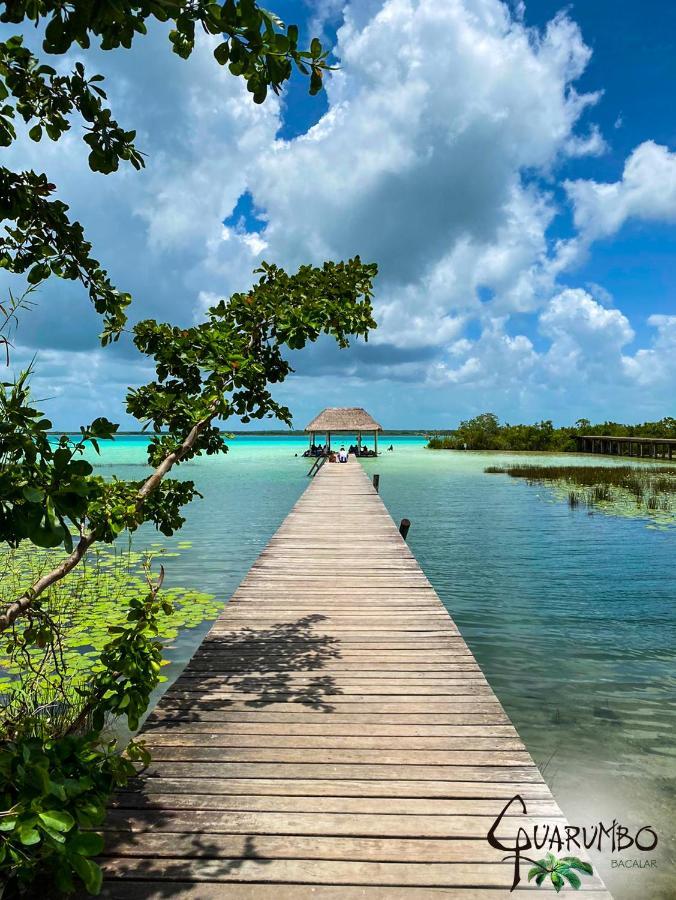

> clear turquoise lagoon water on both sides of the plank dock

[{"left": 91, "top": 436, "right": 676, "bottom": 900}]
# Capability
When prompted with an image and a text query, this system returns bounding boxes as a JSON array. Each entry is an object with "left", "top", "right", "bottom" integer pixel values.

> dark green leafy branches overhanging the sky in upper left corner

[{"left": 0, "top": 0, "right": 328, "bottom": 343}]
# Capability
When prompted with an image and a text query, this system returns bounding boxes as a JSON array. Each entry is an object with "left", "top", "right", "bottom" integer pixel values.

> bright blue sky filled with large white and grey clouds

[{"left": 3, "top": 0, "right": 676, "bottom": 428}]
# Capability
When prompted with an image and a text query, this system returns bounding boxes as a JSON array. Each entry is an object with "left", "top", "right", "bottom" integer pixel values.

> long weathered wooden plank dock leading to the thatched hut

[{"left": 103, "top": 459, "right": 610, "bottom": 900}]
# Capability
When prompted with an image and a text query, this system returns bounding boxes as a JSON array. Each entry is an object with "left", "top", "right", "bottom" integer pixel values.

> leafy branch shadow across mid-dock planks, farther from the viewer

[{"left": 143, "top": 614, "right": 341, "bottom": 733}]
